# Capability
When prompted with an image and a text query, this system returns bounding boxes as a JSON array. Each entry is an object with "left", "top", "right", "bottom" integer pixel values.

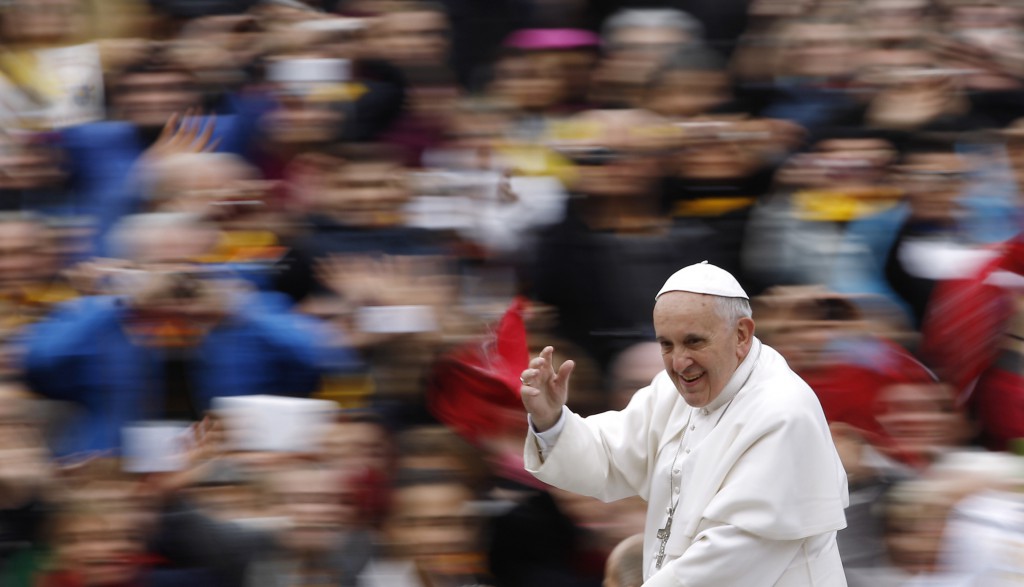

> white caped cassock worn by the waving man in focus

[{"left": 524, "top": 338, "right": 849, "bottom": 587}]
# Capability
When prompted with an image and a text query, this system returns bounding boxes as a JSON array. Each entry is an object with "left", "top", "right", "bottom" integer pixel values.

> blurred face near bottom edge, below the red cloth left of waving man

[{"left": 385, "top": 483, "right": 475, "bottom": 560}]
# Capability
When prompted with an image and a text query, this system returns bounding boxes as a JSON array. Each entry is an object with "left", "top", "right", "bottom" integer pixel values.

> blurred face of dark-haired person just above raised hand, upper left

[{"left": 113, "top": 71, "right": 200, "bottom": 128}]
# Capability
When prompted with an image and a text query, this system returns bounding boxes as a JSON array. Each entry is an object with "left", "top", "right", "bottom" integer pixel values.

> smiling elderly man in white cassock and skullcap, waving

[{"left": 521, "top": 262, "right": 849, "bottom": 587}]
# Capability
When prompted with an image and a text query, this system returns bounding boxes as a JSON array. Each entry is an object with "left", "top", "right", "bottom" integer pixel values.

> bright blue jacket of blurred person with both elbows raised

[{"left": 26, "top": 293, "right": 358, "bottom": 455}]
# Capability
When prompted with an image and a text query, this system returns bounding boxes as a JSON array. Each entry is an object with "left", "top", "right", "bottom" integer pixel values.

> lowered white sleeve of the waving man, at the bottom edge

[{"left": 643, "top": 526, "right": 806, "bottom": 587}]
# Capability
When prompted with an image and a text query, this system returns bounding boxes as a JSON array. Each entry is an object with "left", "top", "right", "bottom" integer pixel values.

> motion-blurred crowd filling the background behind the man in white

[{"left": 0, "top": 0, "right": 1024, "bottom": 587}]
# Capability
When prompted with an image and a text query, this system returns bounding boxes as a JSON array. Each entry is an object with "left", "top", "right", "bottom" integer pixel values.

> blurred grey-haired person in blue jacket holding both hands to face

[{"left": 26, "top": 213, "right": 355, "bottom": 454}]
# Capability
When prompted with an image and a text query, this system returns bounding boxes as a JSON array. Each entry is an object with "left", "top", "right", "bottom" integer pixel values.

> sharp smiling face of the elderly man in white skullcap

[{"left": 654, "top": 292, "right": 754, "bottom": 408}]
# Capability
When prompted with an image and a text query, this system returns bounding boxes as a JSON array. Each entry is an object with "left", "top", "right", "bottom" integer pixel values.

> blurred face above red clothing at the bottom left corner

[{"left": 56, "top": 512, "right": 144, "bottom": 587}]
